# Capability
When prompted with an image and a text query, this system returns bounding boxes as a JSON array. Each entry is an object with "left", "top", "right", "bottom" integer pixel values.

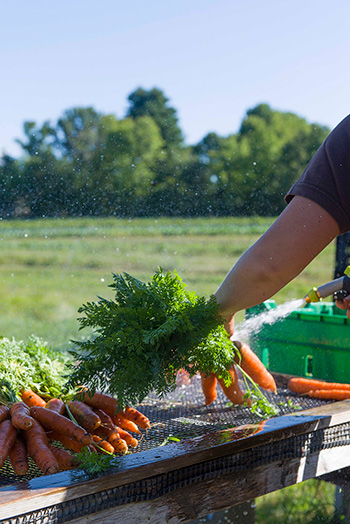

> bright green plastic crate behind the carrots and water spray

[{"left": 246, "top": 300, "right": 350, "bottom": 383}]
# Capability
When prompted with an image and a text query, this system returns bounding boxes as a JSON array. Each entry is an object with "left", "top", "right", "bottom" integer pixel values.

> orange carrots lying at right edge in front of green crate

[{"left": 288, "top": 377, "right": 350, "bottom": 400}]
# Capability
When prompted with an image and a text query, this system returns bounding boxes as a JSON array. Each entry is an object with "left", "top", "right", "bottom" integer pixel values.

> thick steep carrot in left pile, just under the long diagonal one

[{"left": 23, "top": 418, "right": 60, "bottom": 475}]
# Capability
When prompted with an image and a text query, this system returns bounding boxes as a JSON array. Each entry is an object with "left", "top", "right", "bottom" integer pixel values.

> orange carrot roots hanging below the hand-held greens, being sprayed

[{"left": 201, "top": 341, "right": 277, "bottom": 406}]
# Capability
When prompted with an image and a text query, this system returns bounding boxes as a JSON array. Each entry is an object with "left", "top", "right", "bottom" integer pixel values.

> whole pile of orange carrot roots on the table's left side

[{"left": 0, "top": 389, "right": 150, "bottom": 475}]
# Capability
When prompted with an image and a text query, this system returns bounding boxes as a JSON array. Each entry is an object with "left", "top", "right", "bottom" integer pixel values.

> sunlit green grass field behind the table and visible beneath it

[{"left": 0, "top": 218, "right": 335, "bottom": 524}]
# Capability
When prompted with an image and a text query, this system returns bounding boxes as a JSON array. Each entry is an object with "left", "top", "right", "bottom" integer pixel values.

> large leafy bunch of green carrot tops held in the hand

[{"left": 69, "top": 270, "right": 234, "bottom": 407}]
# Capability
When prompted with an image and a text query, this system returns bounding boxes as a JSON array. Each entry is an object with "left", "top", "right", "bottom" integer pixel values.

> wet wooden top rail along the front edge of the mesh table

[{"left": 0, "top": 401, "right": 350, "bottom": 519}]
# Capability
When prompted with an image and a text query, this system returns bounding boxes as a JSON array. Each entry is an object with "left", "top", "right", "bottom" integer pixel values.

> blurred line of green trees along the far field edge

[{"left": 0, "top": 88, "right": 329, "bottom": 218}]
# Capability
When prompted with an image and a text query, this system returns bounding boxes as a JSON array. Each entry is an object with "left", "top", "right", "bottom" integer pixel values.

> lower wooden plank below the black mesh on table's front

[{"left": 65, "top": 448, "right": 350, "bottom": 524}]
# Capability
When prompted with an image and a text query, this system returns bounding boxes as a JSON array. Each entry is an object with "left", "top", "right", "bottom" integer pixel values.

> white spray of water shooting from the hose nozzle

[{"left": 231, "top": 298, "right": 305, "bottom": 342}]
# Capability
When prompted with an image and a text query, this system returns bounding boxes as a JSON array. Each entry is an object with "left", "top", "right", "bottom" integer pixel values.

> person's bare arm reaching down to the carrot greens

[{"left": 215, "top": 196, "right": 340, "bottom": 324}]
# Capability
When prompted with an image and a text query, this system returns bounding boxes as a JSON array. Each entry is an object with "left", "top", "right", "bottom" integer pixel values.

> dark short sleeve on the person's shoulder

[{"left": 285, "top": 115, "right": 350, "bottom": 233}]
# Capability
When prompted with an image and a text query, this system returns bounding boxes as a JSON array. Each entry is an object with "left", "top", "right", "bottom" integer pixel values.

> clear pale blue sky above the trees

[{"left": 0, "top": 0, "right": 350, "bottom": 156}]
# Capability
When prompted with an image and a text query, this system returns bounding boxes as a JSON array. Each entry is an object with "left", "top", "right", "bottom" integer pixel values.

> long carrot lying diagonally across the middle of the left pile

[{"left": 30, "top": 406, "right": 92, "bottom": 446}]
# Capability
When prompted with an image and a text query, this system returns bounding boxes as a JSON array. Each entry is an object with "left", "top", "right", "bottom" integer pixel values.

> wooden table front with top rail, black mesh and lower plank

[{"left": 0, "top": 401, "right": 350, "bottom": 524}]
